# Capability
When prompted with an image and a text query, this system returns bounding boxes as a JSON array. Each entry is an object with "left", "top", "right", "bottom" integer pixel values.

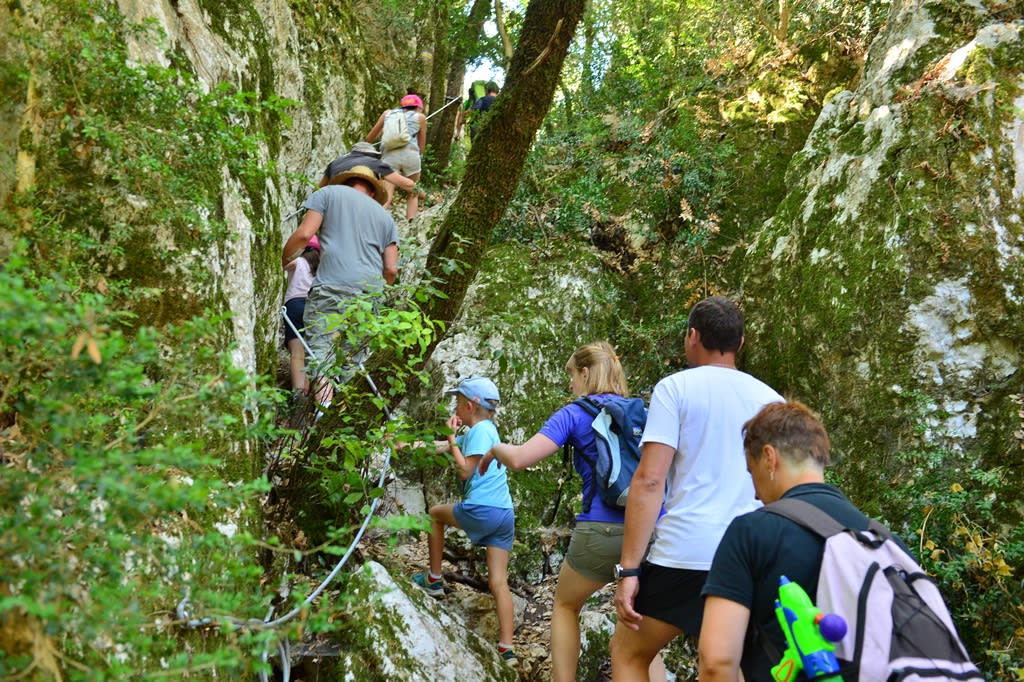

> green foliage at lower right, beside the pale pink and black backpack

[{"left": 868, "top": 394, "right": 1024, "bottom": 679}]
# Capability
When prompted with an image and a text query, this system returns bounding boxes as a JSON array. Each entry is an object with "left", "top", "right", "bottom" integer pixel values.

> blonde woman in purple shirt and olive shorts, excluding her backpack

[{"left": 480, "top": 341, "right": 666, "bottom": 682}]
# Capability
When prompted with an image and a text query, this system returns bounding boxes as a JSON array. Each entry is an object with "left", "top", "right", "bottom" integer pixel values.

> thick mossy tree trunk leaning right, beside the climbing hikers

[{"left": 426, "top": 0, "right": 585, "bottom": 339}]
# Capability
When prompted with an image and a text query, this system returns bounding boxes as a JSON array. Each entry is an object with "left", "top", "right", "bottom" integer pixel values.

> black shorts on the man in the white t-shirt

[{"left": 633, "top": 561, "right": 708, "bottom": 637}]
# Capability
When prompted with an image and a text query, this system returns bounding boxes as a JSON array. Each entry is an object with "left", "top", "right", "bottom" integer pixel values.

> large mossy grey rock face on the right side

[{"left": 736, "top": 1, "right": 1024, "bottom": 509}]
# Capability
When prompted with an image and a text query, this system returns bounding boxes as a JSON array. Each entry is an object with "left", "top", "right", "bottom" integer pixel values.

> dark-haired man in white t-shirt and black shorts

[{"left": 611, "top": 296, "right": 783, "bottom": 682}]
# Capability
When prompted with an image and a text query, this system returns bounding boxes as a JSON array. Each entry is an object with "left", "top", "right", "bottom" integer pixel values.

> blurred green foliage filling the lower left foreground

[{"left": 0, "top": 244, "right": 284, "bottom": 680}]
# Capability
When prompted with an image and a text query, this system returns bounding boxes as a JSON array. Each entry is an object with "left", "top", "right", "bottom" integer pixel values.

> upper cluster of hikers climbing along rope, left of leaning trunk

[{"left": 282, "top": 81, "right": 498, "bottom": 413}]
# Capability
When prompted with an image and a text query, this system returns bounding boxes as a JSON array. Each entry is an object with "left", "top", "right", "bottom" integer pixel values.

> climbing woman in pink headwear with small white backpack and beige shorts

[{"left": 367, "top": 93, "right": 427, "bottom": 220}]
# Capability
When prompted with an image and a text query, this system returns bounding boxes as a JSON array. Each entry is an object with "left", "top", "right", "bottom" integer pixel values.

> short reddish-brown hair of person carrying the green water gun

[{"left": 743, "top": 400, "right": 831, "bottom": 467}]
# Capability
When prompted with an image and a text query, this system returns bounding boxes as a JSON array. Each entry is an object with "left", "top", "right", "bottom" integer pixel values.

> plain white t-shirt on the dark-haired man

[{"left": 641, "top": 365, "right": 783, "bottom": 570}]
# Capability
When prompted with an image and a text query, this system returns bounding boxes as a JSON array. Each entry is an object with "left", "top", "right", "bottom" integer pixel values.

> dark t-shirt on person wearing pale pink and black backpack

[{"left": 701, "top": 483, "right": 880, "bottom": 682}]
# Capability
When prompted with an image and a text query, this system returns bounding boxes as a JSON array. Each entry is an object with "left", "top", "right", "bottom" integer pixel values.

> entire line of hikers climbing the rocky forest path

[{"left": 282, "top": 83, "right": 983, "bottom": 682}]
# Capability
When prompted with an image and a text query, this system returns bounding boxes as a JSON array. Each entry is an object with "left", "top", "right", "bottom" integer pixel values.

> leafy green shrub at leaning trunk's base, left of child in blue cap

[{"left": 268, "top": 278, "right": 443, "bottom": 541}]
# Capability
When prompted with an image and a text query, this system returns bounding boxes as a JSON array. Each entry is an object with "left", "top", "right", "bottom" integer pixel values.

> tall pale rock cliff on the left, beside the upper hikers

[{"left": 0, "top": 0, "right": 422, "bottom": 372}]
